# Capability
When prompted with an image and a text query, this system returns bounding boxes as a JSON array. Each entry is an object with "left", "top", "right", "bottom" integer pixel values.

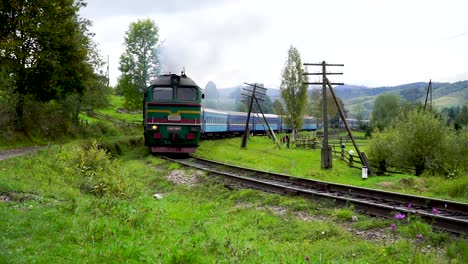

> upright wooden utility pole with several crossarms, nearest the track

[{"left": 303, "top": 61, "right": 344, "bottom": 169}]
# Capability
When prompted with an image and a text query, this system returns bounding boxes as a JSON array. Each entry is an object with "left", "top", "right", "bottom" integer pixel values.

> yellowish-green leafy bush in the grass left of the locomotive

[{"left": 65, "top": 141, "right": 133, "bottom": 197}]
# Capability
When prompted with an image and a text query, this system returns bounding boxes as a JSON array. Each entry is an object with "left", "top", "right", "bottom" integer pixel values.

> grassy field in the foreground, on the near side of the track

[{"left": 0, "top": 138, "right": 468, "bottom": 263}]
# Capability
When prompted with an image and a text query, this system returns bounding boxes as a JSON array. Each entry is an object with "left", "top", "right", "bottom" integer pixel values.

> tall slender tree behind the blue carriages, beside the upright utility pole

[{"left": 280, "top": 46, "right": 308, "bottom": 132}]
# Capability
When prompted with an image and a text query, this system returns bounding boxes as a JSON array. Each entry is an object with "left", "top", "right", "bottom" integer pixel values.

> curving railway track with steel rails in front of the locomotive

[{"left": 163, "top": 157, "right": 468, "bottom": 236}]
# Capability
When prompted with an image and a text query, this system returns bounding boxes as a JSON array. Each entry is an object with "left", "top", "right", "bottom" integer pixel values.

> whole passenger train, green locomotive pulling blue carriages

[{"left": 143, "top": 73, "right": 366, "bottom": 154}]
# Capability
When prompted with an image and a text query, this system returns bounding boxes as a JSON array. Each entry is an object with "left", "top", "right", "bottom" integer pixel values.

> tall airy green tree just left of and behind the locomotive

[{"left": 118, "top": 19, "right": 160, "bottom": 109}]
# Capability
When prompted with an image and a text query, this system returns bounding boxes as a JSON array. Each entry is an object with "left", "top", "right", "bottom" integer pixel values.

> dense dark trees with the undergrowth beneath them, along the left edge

[{"left": 0, "top": 0, "right": 110, "bottom": 140}]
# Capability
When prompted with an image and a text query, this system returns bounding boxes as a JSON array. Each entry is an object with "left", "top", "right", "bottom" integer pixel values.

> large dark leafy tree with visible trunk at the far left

[{"left": 0, "top": 0, "right": 93, "bottom": 131}]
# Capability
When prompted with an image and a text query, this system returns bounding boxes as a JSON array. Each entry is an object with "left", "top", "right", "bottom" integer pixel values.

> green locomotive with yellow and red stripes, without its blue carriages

[{"left": 143, "top": 74, "right": 202, "bottom": 153}]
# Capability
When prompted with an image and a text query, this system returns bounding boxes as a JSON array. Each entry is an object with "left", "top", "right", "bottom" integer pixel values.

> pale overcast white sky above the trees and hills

[{"left": 81, "top": 0, "right": 468, "bottom": 88}]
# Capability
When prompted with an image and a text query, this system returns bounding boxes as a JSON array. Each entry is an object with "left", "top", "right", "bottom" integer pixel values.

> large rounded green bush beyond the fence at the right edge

[{"left": 369, "top": 109, "right": 468, "bottom": 176}]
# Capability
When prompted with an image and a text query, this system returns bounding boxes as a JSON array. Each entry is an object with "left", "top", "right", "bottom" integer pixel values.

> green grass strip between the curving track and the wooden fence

[{"left": 196, "top": 136, "right": 468, "bottom": 202}]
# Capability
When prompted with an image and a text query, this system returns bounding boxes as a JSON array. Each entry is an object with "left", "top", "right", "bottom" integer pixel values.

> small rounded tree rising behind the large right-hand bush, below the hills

[{"left": 371, "top": 94, "right": 402, "bottom": 131}]
